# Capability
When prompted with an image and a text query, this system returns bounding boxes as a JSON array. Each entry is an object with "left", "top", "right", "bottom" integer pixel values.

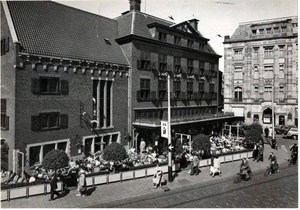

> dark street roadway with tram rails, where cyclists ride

[{"left": 90, "top": 164, "right": 298, "bottom": 208}]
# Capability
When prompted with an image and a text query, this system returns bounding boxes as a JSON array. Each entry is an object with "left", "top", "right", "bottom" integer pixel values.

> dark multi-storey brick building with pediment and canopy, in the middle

[{"left": 115, "top": 0, "right": 233, "bottom": 151}]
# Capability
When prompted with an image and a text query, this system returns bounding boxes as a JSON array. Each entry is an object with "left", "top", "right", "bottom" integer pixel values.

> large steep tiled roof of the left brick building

[{"left": 7, "top": 1, "right": 128, "bottom": 64}]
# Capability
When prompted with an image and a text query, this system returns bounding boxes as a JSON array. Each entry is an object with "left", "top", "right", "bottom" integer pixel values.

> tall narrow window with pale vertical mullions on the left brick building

[{"left": 93, "top": 80, "right": 113, "bottom": 128}]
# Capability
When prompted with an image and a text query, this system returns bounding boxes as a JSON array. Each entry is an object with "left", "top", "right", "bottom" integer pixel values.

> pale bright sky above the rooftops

[{"left": 55, "top": 0, "right": 298, "bottom": 71}]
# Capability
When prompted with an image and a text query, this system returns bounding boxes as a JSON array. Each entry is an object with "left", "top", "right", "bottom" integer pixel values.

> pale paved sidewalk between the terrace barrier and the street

[{"left": 1, "top": 144, "right": 289, "bottom": 208}]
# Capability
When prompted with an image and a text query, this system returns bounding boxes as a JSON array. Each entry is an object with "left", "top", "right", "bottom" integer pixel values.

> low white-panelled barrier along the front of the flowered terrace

[{"left": 1, "top": 151, "right": 252, "bottom": 201}]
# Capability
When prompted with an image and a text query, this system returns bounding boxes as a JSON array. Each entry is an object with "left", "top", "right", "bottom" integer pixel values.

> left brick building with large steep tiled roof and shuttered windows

[{"left": 1, "top": 1, "right": 129, "bottom": 169}]
